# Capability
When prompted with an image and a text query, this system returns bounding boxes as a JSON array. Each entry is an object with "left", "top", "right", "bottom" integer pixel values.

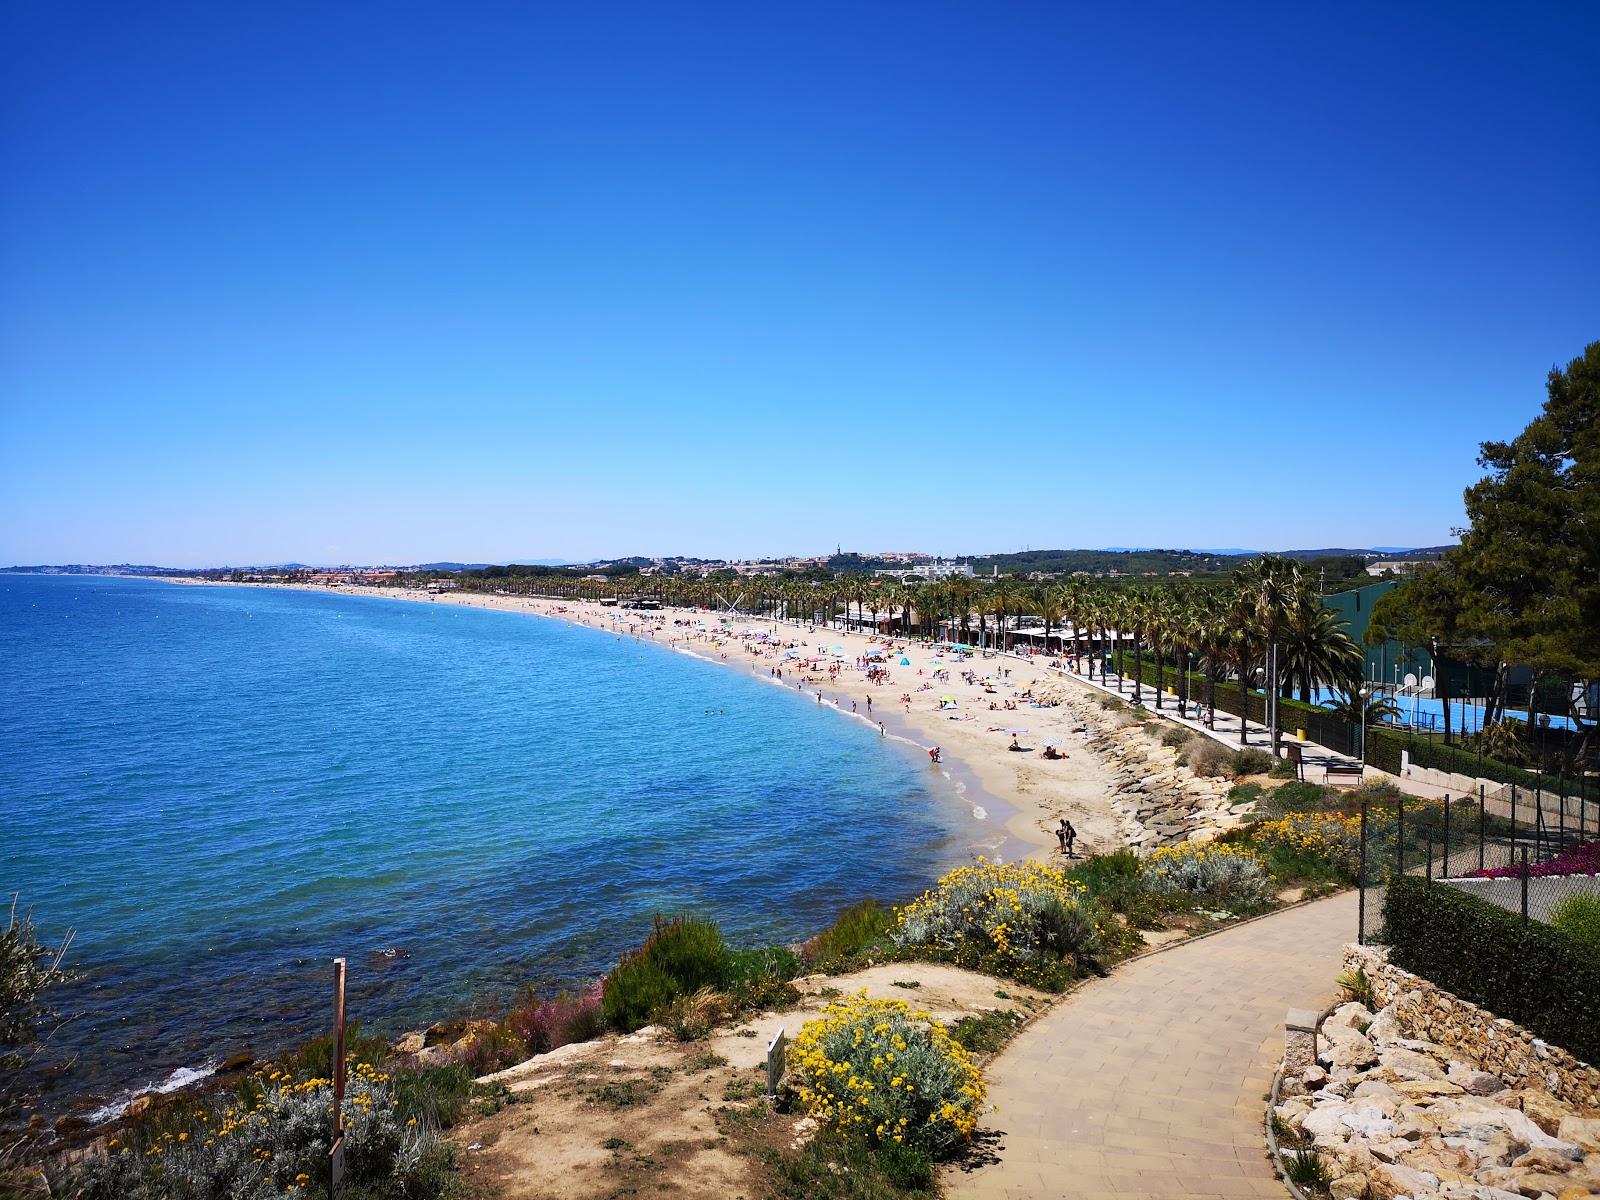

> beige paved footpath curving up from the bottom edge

[{"left": 944, "top": 893, "right": 1357, "bottom": 1200}]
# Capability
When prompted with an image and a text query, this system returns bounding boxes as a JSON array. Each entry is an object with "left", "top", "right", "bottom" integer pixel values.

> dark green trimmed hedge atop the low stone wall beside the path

[{"left": 1384, "top": 875, "right": 1600, "bottom": 1062}]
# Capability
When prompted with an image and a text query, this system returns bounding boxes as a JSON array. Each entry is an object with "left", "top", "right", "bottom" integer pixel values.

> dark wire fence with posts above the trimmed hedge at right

[{"left": 1358, "top": 784, "right": 1600, "bottom": 941}]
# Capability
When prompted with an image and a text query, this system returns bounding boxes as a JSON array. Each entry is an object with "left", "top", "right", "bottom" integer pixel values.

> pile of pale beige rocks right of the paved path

[{"left": 1274, "top": 1002, "right": 1600, "bottom": 1200}]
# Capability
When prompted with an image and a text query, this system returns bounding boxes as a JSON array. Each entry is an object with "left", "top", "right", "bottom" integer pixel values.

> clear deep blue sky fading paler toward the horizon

[{"left": 0, "top": 0, "right": 1600, "bottom": 565}]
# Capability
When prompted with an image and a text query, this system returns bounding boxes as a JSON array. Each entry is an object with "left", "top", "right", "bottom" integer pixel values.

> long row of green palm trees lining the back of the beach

[{"left": 444, "top": 555, "right": 1363, "bottom": 752}]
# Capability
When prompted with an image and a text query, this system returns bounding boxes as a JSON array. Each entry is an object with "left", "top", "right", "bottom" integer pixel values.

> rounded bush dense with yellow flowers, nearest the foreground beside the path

[{"left": 789, "top": 989, "right": 984, "bottom": 1157}]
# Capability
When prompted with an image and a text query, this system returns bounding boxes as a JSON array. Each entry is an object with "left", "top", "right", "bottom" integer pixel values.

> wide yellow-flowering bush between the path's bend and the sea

[{"left": 893, "top": 858, "right": 1098, "bottom": 978}]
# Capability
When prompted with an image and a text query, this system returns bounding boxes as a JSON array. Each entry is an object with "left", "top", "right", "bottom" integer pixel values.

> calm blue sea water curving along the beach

[{"left": 0, "top": 576, "right": 984, "bottom": 1106}]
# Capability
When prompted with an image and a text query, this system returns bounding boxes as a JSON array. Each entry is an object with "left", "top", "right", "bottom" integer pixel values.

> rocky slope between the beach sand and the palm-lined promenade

[{"left": 1035, "top": 683, "right": 1250, "bottom": 853}]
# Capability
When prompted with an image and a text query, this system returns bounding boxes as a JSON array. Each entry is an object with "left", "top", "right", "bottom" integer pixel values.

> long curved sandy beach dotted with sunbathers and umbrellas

[{"left": 176, "top": 579, "right": 1126, "bottom": 859}]
